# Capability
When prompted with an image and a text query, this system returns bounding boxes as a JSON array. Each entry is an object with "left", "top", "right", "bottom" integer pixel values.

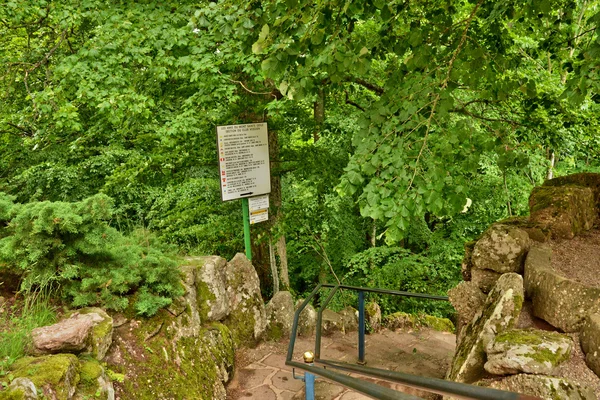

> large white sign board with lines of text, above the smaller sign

[{"left": 217, "top": 123, "right": 271, "bottom": 201}]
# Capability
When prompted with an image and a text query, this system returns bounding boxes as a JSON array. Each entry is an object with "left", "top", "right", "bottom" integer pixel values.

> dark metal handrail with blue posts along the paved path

[{"left": 285, "top": 284, "right": 541, "bottom": 400}]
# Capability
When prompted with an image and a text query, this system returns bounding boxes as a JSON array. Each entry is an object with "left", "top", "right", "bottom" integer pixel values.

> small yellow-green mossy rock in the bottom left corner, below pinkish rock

[{"left": 11, "top": 354, "right": 79, "bottom": 400}]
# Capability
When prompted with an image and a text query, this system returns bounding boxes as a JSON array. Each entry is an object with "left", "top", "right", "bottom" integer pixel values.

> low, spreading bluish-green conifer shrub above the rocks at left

[{"left": 0, "top": 195, "right": 182, "bottom": 315}]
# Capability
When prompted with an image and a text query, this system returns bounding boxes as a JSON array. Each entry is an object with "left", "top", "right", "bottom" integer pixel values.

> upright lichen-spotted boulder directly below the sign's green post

[{"left": 224, "top": 253, "right": 267, "bottom": 345}]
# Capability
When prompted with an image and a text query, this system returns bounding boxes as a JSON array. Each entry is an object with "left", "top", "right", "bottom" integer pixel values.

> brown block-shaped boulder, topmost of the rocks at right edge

[{"left": 529, "top": 186, "right": 597, "bottom": 239}]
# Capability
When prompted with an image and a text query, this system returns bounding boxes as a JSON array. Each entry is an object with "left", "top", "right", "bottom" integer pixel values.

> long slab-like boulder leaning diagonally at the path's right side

[{"left": 447, "top": 273, "right": 524, "bottom": 383}]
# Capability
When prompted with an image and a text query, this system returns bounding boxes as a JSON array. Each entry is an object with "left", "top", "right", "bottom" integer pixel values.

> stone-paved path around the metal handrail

[{"left": 227, "top": 329, "right": 455, "bottom": 400}]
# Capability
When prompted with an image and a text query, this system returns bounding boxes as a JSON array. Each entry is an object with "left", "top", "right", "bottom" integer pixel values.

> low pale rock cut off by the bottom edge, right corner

[{"left": 489, "top": 374, "right": 596, "bottom": 400}]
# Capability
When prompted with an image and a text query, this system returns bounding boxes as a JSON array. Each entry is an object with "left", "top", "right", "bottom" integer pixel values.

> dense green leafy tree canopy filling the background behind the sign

[{"left": 0, "top": 0, "right": 600, "bottom": 306}]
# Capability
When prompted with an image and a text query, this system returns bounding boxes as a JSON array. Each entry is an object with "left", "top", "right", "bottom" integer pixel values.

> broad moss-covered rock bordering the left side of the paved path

[{"left": 106, "top": 310, "right": 235, "bottom": 400}]
